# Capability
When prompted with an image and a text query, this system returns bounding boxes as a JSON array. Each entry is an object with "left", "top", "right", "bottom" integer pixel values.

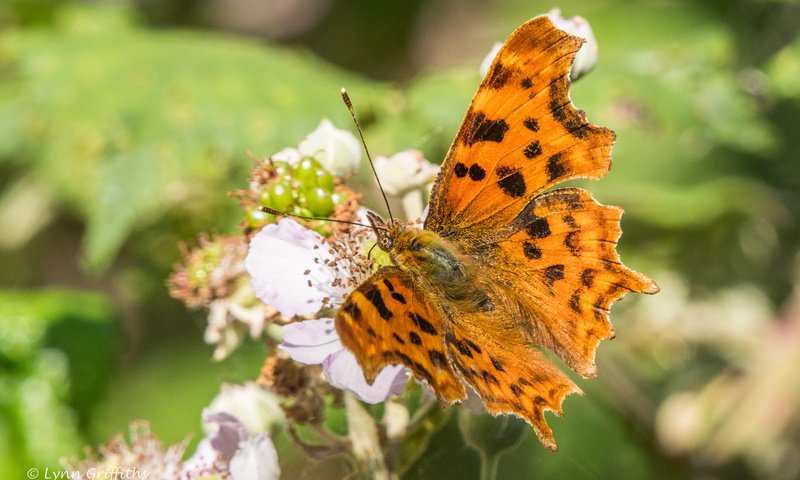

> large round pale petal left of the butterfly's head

[{"left": 245, "top": 218, "right": 334, "bottom": 317}]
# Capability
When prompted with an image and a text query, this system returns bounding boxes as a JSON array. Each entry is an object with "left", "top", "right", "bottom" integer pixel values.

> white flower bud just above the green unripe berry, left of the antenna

[{"left": 297, "top": 118, "right": 361, "bottom": 177}]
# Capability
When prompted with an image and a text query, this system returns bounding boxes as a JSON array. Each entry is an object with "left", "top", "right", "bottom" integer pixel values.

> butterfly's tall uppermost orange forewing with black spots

[{"left": 425, "top": 16, "right": 615, "bottom": 237}]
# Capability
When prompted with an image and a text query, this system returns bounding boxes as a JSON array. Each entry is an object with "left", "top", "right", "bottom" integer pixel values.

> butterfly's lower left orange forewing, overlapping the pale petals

[{"left": 336, "top": 267, "right": 466, "bottom": 403}]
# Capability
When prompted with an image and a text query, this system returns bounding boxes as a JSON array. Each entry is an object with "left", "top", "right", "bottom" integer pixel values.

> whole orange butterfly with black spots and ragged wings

[{"left": 335, "top": 16, "right": 659, "bottom": 450}]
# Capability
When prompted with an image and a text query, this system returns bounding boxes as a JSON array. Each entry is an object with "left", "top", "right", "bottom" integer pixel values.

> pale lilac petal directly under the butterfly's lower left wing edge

[{"left": 323, "top": 350, "right": 408, "bottom": 403}]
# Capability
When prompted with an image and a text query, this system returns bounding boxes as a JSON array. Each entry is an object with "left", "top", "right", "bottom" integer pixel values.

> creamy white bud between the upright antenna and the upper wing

[{"left": 374, "top": 150, "right": 439, "bottom": 195}]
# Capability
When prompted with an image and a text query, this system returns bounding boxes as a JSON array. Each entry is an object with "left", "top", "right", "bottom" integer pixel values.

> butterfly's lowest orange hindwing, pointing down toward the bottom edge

[{"left": 446, "top": 310, "right": 582, "bottom": 450}]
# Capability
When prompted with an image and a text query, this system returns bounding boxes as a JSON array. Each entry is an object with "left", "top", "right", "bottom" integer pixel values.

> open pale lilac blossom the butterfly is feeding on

[{"left": 245, "top": 219, "right": 407, "bottom": 403}]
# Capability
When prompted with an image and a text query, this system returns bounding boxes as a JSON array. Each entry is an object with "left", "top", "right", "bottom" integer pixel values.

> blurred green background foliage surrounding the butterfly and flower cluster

[{"left": 0, "top": 0, "right": 800, "bottom": 479}]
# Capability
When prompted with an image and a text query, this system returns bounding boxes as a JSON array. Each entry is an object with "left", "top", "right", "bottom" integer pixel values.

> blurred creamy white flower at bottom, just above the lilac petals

[{"left": 206, "top": 382, "right": 284, "bottom": 433}]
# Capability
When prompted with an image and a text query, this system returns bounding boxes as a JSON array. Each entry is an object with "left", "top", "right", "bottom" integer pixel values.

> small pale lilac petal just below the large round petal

[{"left": 278, "top": 318, "right": 342, "bottom": 365}]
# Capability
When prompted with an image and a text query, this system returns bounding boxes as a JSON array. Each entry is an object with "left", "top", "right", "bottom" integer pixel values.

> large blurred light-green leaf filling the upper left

[{"left": 0, "top": 7, "right": 384, "bottom": 270}]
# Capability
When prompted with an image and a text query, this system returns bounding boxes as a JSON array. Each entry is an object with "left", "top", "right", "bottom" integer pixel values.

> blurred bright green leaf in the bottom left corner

[{"left": 0, "top": 290, "right": 121, "bottom": 478}]
